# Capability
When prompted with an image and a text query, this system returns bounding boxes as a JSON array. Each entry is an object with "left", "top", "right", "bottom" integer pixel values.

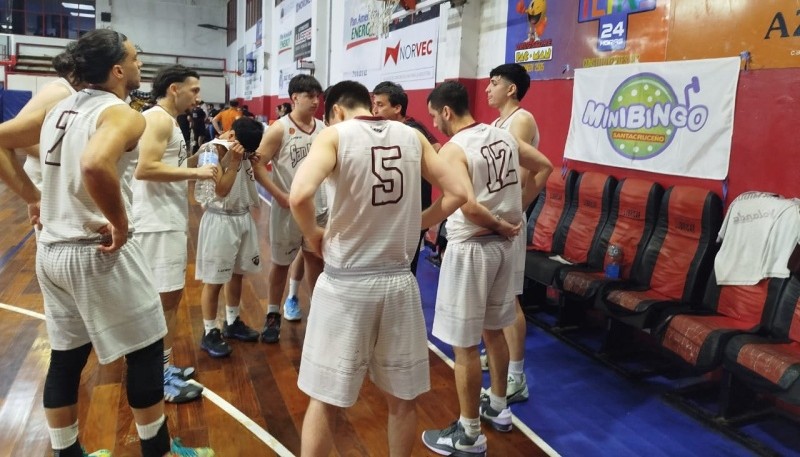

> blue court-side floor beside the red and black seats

[{"left": 417, "top": 249, "right": 800, "bottom": 457}]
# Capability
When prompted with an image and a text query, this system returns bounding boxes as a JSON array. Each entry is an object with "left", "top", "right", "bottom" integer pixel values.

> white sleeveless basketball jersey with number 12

[{"left": 446, "top": 123, "right": 522, "bottom": 242}]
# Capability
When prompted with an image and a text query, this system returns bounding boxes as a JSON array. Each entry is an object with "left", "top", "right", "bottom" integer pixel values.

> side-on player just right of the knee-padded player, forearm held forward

[{"left": 131, "top": 65, "right": 217, "bottom": 403}]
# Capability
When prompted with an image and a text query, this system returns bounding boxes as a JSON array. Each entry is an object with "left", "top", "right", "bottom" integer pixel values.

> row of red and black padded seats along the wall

[{"left": 523, "top": 171, "right": 800, "bottom": 414}]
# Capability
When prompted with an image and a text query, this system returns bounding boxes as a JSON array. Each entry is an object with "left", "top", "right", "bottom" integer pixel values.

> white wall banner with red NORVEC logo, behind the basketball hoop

[{"left": 331, "top": 0, "right": 439, "bottom": 90}]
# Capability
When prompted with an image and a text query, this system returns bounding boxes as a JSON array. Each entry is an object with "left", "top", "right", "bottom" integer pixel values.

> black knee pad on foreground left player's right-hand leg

[{"left": 125, "top": 339, "right": 164, "bottom": 409}]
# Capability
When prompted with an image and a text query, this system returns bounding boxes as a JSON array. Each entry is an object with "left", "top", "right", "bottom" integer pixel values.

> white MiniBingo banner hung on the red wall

[{"left": 564, "top": 57, "right": 740, "bottom": 180}]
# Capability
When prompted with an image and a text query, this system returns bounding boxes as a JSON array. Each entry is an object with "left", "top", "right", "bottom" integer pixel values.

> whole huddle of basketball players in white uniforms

[{"left": 0, "top": 29, "right": 552, "bottom": 457}]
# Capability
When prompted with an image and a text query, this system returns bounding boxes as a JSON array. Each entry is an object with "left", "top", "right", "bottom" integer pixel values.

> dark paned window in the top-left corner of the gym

[{"left": 0, "top": 0, "right": 96, "bottom": 39}]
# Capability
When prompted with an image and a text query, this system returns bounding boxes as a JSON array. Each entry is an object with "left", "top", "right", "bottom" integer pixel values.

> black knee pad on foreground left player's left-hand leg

[{"left": 43, "top": 343, "right": 92, "bottom": 408}]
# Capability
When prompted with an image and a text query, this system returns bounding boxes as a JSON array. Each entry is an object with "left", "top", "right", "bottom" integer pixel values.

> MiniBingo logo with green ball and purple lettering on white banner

[{"left": 581, "top": 73, "right": 708, "bottom": 160}]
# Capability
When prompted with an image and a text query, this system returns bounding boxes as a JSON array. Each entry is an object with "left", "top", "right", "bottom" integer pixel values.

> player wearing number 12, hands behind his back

[{"left": 422, "top": 81, "right": 550, "bottom": 455}]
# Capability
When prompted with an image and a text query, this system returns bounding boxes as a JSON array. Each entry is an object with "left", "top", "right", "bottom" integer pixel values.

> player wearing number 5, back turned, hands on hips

[{"left": 289, "top": 81, "right": 466, "bottom": 456}]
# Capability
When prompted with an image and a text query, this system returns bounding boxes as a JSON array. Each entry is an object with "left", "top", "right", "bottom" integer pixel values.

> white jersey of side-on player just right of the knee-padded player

[{"left": 131, "top": 105, "right": 189, "bottom": 232}]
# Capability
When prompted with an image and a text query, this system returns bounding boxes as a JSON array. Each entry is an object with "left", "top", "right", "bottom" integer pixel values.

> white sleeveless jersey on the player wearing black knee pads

[{"left": 39, "top": 89, "right": 133, "bottom": 243}]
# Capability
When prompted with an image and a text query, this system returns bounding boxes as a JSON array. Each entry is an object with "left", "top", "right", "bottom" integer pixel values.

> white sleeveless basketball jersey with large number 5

[{"left": 323, "top": 117, "right": 422, "bottom": 272}]
